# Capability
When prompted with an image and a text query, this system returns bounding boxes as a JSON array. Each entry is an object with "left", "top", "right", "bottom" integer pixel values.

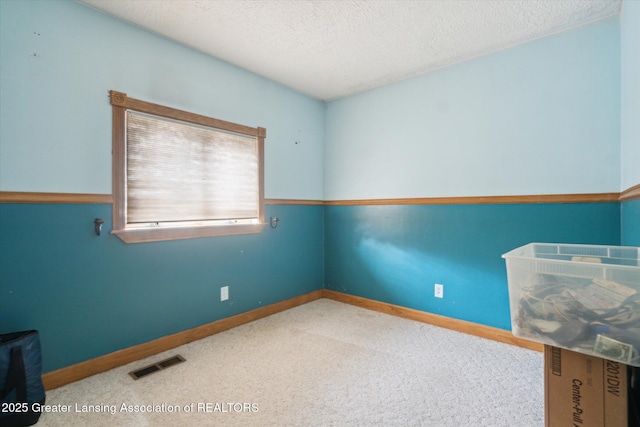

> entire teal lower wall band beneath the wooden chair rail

[{"left": 0, "top": 200, "right": 640, "bottom": 372}]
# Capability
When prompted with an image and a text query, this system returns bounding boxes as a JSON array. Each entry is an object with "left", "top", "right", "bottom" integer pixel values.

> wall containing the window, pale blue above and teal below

[{"left": 0, "top": 0, "right": 324, "bottom": 371}]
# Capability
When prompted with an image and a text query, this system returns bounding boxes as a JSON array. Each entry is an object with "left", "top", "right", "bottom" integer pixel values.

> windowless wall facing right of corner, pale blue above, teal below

[{"left": 324, "top": 13, "right": 633, "bottom": 329}]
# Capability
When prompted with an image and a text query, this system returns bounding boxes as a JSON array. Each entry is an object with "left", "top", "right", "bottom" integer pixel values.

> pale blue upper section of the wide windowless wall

[{"left": 324, "top": 17, "right": 620, "bottom": 200}]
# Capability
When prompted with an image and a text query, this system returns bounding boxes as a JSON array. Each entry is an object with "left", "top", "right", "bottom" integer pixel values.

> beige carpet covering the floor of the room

[{"left": 38, "top": 299, "right": 544, "bottom": 427}]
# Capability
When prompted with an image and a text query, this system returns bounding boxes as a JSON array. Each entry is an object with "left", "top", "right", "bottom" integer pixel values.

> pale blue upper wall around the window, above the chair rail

[{"left": 0, "top": 1, "right": 324, "bottom": 200}]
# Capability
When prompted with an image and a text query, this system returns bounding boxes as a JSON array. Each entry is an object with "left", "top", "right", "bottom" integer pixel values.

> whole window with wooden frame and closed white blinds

[{"left": 110, "top": 91, "right": 266, "bottom": 243}]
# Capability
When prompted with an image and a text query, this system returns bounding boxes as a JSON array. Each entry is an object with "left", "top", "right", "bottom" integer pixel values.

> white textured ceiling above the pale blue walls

[{"left": 81, "top": 0, "right": 622, "bottom": 100}]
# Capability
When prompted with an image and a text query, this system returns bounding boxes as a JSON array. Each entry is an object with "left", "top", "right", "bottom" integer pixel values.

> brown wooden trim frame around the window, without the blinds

[{"left": 109, "top": 90, "right": 267, "bottom": 243}]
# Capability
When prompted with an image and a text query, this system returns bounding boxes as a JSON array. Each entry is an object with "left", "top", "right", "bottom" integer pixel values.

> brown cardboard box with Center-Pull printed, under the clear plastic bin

[{"left": 544, "top": 345, "right": 628, "bottom": 427}]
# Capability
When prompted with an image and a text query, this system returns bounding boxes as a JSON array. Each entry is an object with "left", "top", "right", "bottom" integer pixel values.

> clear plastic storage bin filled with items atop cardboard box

[{"left": 502, "top": 243, "right": 640, "bottom": 366}]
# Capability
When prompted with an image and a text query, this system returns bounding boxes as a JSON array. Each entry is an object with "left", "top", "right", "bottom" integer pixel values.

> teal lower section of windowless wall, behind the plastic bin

[{"left": 325, "top": 203, "right": 620, "bottom": 329}]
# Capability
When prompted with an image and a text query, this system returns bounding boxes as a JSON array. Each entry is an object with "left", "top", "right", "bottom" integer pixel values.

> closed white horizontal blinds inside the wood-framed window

[{"left": 126, "top": 110, "right": 259, "bottom": 225}]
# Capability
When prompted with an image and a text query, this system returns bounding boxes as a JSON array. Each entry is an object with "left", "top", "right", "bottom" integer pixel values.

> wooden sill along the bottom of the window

[{"left": 111, "top": 223, "right": 267, "bottom": 243}]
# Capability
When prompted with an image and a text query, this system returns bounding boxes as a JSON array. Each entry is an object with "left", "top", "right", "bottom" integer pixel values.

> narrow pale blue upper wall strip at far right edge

[{"left": 620, "top": 0, "right": 640, "bottom": 191}]
